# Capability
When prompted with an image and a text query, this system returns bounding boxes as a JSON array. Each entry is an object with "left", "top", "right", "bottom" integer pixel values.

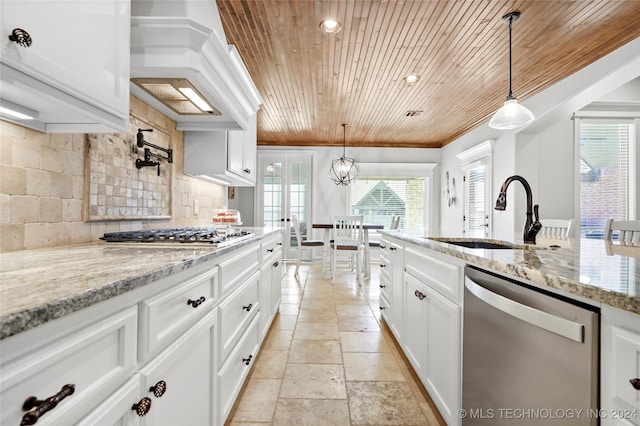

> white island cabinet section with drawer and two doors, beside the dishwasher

[{"left": 401, "top": 246, "right": 464, "bottom": 424}]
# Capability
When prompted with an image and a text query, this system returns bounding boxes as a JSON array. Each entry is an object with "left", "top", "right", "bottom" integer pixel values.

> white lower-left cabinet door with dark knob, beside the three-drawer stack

[{"left": 140, "top": 310, "right": 217, "bottom": 426}]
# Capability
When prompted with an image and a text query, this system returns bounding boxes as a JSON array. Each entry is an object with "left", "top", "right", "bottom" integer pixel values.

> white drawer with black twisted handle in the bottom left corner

[{"left": 0, "top": 306, "right": 138, "bottom": 425}]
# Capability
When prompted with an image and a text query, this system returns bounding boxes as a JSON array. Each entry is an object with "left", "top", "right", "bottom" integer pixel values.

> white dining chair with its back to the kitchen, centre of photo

[{"left": 329, "top": 216, "right": 364, "bottom": 282}]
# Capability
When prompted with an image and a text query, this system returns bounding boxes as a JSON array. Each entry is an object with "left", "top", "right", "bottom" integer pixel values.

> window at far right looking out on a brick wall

[{"left": 577, "top": 118, "right": 635, "bottom": 238}]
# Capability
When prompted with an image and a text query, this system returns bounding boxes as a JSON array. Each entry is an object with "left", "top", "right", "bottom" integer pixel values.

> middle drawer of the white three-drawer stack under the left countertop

[{"left": 218, "top": 272, "right": 260, "bottom": 362}]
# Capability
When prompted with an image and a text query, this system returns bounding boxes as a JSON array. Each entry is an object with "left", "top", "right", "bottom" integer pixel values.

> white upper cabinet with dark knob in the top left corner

[{"left": 0, "top": 0, "right": 131, "bottom": 132}]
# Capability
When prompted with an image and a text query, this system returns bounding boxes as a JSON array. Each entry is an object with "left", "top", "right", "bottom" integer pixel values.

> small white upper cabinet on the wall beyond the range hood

[{"left": 184, "top": 114, "right": 257, "bottom": 186}]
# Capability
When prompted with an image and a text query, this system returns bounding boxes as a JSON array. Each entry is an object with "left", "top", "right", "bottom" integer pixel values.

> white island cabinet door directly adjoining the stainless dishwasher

[{"left": 420, "top": 287, "right": 462, "bottom": 424}]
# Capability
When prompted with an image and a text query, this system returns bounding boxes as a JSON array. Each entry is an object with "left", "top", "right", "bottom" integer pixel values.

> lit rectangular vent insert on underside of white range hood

[{"left": 131, "top": 78, "right": 222, "bottom": 115}]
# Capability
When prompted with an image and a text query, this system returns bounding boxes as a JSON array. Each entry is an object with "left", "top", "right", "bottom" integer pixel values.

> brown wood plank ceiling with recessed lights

[{"left": 217, "top": 0, "right": 640, "bottom": 148}]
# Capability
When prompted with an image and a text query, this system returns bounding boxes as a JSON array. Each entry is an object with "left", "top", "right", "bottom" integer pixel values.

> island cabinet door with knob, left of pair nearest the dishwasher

[{"left": 403, "top": 274, "right": 428, "bottom": 376}]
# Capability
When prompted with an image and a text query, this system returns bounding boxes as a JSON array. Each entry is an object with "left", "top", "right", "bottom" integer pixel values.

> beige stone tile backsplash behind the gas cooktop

[{"left": 0, "top": 96, "right": 227, "bottom": 252}]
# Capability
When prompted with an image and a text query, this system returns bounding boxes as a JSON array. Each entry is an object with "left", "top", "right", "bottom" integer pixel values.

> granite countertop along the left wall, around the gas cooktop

[{"left": 0, "top": 228, "right": 281, "bottom": 339}]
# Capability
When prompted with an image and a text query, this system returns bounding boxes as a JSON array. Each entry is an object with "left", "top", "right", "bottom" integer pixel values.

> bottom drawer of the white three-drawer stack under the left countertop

[{"left": 218, "top": 314, "right": 260, "bottom": 424}]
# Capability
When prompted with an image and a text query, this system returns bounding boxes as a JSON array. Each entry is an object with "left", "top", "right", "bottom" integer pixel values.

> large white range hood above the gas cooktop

[{"left": 131, "top": 0, "right": 262, "bottom": 131}]
